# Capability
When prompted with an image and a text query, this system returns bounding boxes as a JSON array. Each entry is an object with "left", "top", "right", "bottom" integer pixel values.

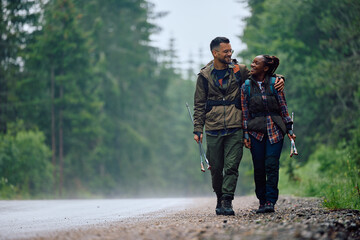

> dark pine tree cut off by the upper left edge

[{"left": 0, "top": 0, "right": 39, "bottom": 133}]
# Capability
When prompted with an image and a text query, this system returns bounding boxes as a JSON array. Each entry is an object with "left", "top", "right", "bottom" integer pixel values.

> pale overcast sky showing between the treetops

[{"left": 149, "top": 0, "right": 250, "bottom": 72}]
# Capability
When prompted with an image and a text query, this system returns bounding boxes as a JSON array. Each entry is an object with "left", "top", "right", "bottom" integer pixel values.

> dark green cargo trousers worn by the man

[{"left": 206, "top": 129, "right": 243, "bottom": 199}]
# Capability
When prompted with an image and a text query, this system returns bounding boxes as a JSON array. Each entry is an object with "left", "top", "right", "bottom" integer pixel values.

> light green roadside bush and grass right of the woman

[{"left": 279, "top": 142, "right": 360, "bottom": 210}]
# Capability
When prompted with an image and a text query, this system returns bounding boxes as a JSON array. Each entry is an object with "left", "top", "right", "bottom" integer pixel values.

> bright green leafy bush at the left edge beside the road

[{"left": 0, "top": 123, "right": 53, "bottom": 198}]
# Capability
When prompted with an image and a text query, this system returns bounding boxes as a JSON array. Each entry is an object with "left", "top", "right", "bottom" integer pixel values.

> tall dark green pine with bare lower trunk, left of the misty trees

[{"left": 24, "top": 0, "right": 101, "bottom": 196}]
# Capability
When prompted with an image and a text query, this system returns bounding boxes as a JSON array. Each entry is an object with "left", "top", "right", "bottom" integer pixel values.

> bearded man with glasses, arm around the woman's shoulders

[{"left": 194, "top": 37, "right": 284, "bottom": 215}]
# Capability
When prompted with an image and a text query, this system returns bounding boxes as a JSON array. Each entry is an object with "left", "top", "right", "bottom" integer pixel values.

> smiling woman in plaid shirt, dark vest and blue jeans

[{"left": 241, "top": 55, "right": 296, "bottom": 213}]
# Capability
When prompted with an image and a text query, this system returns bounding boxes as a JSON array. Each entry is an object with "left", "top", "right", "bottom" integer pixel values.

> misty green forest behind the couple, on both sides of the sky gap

[{"left": 0, "top": 0, "right": 360, "bottom": 209}]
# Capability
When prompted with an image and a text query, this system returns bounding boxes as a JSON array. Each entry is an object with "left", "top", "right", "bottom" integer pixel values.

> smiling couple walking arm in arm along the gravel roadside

[{"left": 194, "top": 37, "right": 295, "bottom": 215}]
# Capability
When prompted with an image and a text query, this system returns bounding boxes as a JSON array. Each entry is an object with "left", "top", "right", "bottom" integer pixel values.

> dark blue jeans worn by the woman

[{"left": 250, "top": 135, "right": 284, "bottom": 205}]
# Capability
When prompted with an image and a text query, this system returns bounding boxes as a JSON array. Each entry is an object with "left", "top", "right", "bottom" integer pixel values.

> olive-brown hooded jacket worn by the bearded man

[{"left": 194, "top": 60, "right": 249, "bottom": 133}]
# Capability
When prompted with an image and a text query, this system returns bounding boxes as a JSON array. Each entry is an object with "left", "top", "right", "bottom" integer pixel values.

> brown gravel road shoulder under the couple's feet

[{"left": 26, "top": 197, "right": 360, "bottom": 240}]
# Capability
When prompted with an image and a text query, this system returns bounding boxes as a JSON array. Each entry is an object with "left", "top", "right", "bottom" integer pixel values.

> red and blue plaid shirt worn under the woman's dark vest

[{"left": 241, "top": 80, "right": 292, "bottom": 144}]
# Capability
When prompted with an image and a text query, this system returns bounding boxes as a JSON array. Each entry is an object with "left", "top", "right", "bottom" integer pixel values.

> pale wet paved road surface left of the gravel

[{"left": 0, "top": 198, "right": 192, "bottom": 239}]
